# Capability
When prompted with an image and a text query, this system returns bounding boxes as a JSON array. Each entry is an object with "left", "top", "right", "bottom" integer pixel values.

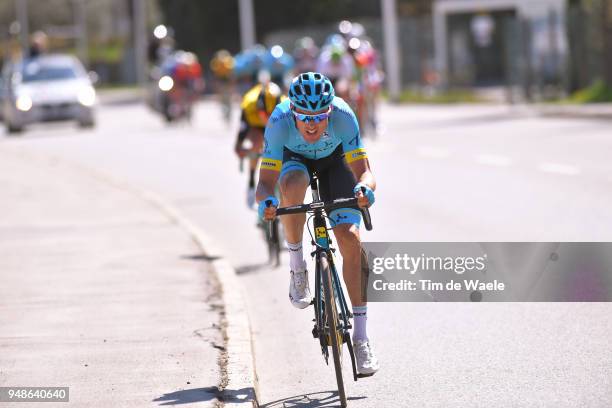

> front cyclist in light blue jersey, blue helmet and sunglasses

[{"left": 257, "top": 72, "right": 378, "bottom": 374}]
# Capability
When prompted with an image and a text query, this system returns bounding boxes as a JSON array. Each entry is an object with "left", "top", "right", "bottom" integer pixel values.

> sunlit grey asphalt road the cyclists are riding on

[{"left": 0, "top": 102, "right": 612, "bottom": 408}]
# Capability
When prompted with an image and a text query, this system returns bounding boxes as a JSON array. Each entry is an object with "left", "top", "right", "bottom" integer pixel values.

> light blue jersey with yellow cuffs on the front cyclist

[{"left": 261, "top": 96, "right": 367, "bottom": 171}]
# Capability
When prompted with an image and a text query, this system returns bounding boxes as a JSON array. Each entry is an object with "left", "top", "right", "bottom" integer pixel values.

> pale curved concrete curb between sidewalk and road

[{"left": 7, "top": 149, "right": 259, "bottom": 408}]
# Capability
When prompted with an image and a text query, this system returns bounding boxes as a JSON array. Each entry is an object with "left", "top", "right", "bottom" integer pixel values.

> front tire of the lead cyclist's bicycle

[{"left": 319, "top": 253, "right": 347, "bottom": 407}]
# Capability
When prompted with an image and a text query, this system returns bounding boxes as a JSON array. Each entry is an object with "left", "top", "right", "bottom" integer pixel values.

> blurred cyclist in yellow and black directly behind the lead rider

[{"left": 234, "top": 73, "right": 282, "bottom": 208}]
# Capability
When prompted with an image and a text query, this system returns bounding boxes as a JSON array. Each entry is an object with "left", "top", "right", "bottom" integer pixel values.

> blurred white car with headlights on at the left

[{"left": 2, "top": 54, "right": 96, "bottom": 133}]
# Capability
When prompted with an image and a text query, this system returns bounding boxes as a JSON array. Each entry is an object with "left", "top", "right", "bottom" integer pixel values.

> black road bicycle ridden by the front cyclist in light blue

[{"left": 266, "top": 173, "right": 372, "bottom": 407}]
